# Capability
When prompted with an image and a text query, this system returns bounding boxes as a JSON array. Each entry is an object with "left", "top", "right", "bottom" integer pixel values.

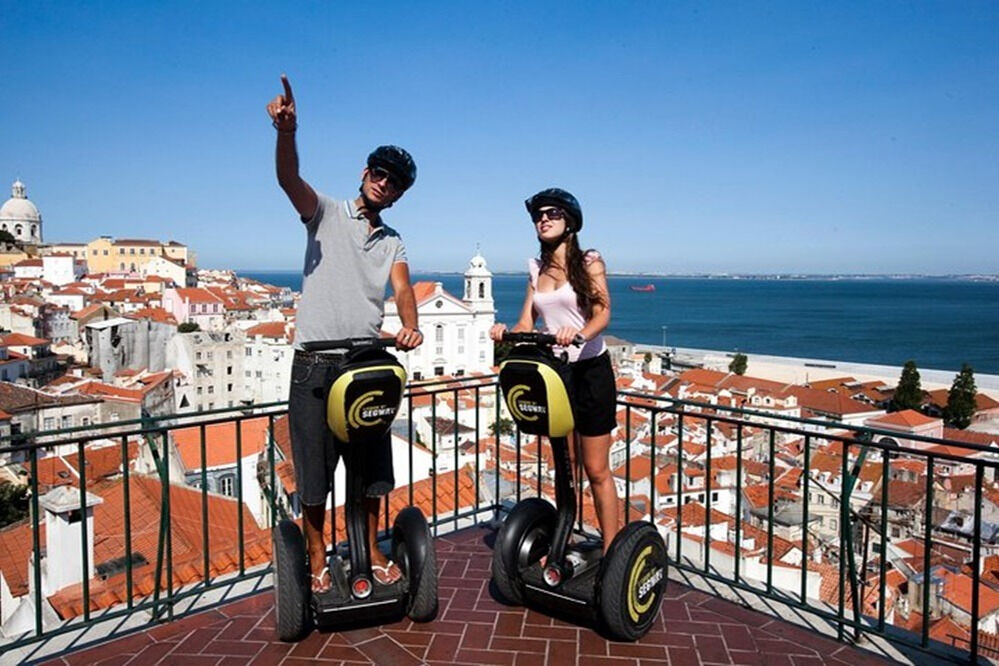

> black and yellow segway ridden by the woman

[{"left": 492, "top": 333, "right": 667, "bottom": 641}]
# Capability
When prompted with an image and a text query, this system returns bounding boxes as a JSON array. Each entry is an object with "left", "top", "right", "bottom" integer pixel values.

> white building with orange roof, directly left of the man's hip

[{"left": 243, "top": 321, "right": 295, "bottom": 404}]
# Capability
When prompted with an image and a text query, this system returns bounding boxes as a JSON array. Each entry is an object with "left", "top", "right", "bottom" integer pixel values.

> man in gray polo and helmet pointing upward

[{"left": 267, "top": 75, "right": 423, "bottom": 593}]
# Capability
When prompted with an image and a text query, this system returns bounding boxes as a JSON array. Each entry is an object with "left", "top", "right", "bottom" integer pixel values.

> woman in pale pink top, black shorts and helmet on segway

[{"left": 490, "top": 188, "right": 618, "bottom": 552}]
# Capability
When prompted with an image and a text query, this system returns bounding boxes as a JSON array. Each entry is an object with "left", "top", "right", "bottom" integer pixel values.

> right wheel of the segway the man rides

[{"left": 392, "top": 506, "right": 438, "bottom": 622}]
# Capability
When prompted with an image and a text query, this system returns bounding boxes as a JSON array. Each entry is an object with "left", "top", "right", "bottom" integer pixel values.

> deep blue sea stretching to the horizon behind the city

[{"left": 239, "top": 271, "right": 999, "bottom": 374}]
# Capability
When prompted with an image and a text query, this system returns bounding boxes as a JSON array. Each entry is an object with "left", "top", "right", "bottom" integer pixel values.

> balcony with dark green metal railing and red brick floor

[{"left": 0, "top": 377, "right": 999, "bottom": 664}]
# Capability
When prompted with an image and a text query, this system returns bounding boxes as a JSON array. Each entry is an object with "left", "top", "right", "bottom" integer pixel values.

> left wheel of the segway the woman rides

[{"left": 492, "top": 497, "right": 557, "bottom": 605}]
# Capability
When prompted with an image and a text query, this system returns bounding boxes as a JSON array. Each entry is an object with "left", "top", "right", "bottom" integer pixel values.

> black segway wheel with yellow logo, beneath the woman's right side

[{"left": 597, "top": 522, "right": 668, "bottom": 641}]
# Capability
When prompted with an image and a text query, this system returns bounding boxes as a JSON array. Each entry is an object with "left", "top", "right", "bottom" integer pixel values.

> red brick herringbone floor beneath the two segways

[{"left": 45, "top": 528, "right": 889, "bottom": 666}]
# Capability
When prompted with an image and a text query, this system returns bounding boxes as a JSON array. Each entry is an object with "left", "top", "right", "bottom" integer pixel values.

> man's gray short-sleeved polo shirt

[{"left": 295, "top": 194, "right": 406, "bottom": 349}]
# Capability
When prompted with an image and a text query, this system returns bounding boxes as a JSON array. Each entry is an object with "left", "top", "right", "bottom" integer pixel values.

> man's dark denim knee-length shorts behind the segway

[{"left": 288, "top": 351, "right": 395, "bottom": 506}]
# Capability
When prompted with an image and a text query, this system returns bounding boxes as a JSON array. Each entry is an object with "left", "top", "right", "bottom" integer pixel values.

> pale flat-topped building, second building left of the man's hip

[{"left": 166, "top": 331, "right": 245, "bottom": 413}]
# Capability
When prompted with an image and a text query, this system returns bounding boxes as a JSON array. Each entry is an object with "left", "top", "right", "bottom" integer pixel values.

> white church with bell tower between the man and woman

[{"left": 382, "top": 254, "right": 496, "bottom": 381}]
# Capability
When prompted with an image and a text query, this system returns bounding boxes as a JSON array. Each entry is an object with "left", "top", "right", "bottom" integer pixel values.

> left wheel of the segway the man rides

[{"left": 273, "top": 520, "right": 310, "bottom": 641}]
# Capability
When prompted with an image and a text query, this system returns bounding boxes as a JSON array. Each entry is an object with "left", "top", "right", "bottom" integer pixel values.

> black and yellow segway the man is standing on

[{"left": 273, "top": 338, "right": 437, "bottom": 641}]
